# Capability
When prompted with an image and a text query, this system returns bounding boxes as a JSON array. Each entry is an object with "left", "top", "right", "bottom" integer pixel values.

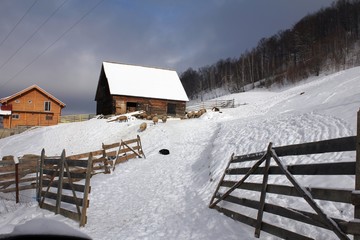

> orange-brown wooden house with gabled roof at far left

[{"left": 0, "top": 85, "right": 65, "bottom": 128}]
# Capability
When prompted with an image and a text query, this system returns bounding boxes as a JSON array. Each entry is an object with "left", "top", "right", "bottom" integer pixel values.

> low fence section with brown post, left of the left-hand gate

[{"left": 0, "top": 154, "right": 40, "bottom": 203}]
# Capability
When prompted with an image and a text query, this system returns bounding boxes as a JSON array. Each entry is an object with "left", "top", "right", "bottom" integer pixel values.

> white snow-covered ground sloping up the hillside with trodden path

[{"left": 0, "top": 68, "right": 360, "bottom": 239}]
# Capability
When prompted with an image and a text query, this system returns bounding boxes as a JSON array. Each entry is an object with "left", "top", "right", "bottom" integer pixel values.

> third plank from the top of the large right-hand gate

[{"left": 221, "top": 181, "right": 353, "bottom": 204}]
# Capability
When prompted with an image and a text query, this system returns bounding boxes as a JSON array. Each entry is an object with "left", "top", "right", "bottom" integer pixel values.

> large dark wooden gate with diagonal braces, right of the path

[{"left": 209, "top": 111, "right": 360, "bottom": 240}]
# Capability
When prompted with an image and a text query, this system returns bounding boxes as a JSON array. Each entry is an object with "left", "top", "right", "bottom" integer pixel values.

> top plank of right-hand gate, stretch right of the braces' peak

[{"left": 273, "top": 136, "right": 356, "bottom": 157}]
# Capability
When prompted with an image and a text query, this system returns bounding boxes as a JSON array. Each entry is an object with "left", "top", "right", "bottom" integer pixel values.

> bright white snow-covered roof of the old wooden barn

[{"left": 103, "top": 62, "right": 189, "bottom": 101}]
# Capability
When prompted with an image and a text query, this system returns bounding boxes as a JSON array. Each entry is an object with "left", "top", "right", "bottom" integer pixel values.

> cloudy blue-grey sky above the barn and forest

[{"left": 0, "top": 0, "right": 333, "bottom": 115}]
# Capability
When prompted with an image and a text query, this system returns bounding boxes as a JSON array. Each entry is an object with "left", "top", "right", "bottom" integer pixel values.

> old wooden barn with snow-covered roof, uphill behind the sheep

[{"left": 95, "top": 62, "right": 189, "bottom": 116}]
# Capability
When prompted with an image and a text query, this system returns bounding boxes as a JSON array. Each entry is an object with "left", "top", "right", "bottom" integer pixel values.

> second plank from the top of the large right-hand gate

[{"left": 226, "top": 162, "right": 356, "bottom": 175}]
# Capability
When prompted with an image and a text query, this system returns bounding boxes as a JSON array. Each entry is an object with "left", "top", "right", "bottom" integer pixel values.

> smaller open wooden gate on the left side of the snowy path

[{"left": 38, "top": 150, "right": 92, "bottom": 226}]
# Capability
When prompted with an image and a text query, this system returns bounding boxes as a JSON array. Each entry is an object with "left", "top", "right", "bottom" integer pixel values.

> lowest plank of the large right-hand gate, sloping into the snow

[{"left": 215, "top": 206, "right": 314, "bottom": 240}]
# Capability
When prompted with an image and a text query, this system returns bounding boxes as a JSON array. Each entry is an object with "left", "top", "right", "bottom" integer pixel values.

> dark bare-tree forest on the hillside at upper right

[{"left": 180, "top": 0, "right": 360, "bottom": 100}]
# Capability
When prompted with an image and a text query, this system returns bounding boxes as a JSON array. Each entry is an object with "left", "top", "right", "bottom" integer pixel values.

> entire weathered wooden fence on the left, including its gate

[{"left": 0, "top": 136, "right": 145, "bottom": 226}]
